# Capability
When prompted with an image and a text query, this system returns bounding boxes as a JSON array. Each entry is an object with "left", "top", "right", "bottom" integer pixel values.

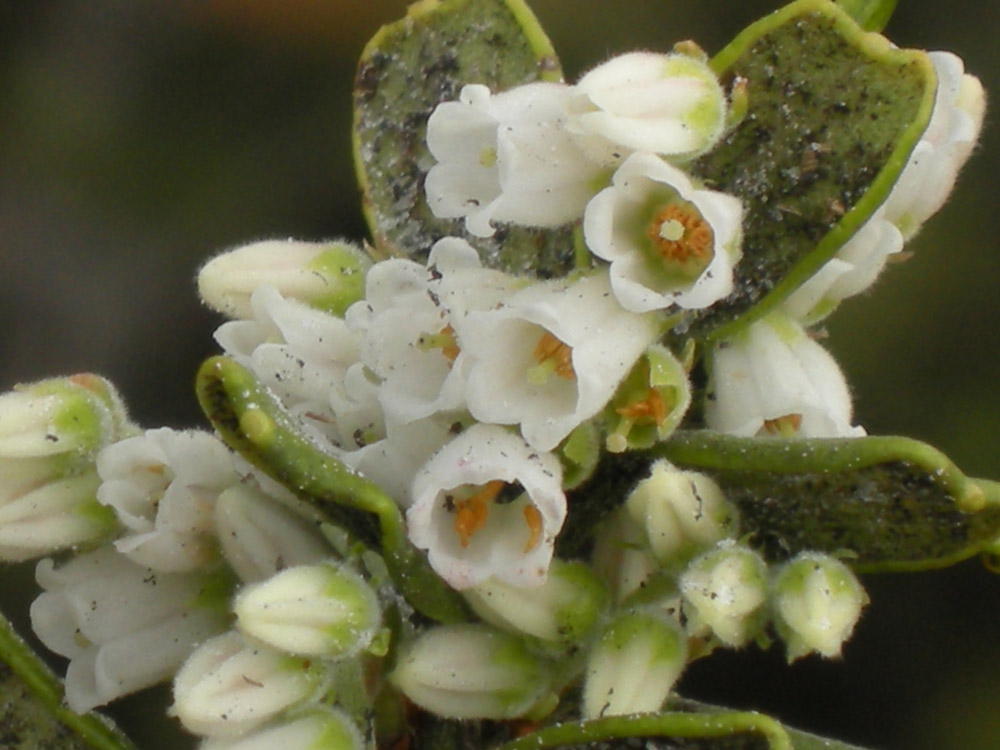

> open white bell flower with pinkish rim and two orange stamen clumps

[{"left": 406, "top": 425, "right": 566, "bottom": 589}]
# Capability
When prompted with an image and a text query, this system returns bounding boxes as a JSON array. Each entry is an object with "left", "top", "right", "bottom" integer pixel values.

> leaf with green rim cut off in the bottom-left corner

[{"left": 0, "top": 615, "right": 136, "bottom": 750}]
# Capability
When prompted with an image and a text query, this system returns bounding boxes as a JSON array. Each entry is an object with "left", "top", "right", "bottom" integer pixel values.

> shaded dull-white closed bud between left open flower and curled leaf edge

[{"left": 215, "top": 484, "right": 332, "bottom": 583}]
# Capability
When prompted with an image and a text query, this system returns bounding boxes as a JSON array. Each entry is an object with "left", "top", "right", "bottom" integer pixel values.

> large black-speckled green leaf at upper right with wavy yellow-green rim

[{"left": 675, "top": 0, "right": 936, "bottom": 338}]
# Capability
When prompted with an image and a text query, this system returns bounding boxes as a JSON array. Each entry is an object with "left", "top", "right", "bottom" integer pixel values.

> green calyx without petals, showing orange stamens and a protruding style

[{"left": 607, "top": 344, "right": 691, "bottom": 453}]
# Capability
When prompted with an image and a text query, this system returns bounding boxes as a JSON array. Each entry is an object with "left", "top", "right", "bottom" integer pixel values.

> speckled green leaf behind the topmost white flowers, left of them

[{"left": 354, "top": 0, "right": 574, "bottom": 275}]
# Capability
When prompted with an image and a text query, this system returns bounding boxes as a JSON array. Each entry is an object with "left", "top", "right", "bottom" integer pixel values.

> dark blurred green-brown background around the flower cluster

[{"left": 0, "top": 0, "right": 1000, "bottom": 750}]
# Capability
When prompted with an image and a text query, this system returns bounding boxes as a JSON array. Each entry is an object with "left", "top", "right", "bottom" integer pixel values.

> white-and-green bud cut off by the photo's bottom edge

[{"left": 198, "top": 706, "right": 367, "bottom": 750}]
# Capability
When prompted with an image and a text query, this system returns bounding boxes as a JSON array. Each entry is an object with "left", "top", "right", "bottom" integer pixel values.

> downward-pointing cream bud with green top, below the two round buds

[{"left": 583, "top": 611, "right": 687, "bottom": 719}]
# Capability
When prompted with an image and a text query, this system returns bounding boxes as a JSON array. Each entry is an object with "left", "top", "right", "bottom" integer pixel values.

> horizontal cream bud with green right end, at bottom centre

[{"left": 392, "top": 624, "right": 549, "bottom": 719}]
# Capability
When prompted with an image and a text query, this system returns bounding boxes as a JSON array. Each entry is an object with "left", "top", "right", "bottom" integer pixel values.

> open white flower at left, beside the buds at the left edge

[{"left": 97, "top": 427, "right": 239, "bottom": 571}]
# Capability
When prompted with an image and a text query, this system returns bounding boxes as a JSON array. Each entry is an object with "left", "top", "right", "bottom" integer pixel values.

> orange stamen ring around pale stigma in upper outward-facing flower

[{"left": 646, "top": 203, "right": 715, "bottom": 278}]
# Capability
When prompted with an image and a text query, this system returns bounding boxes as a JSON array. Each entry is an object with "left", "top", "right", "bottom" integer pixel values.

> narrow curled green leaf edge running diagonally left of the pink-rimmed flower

[{"left": 196, "top": 357, "right": 466, "bottom": 622}]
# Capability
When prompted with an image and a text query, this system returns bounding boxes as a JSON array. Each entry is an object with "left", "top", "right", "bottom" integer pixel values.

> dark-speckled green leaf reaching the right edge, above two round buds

[{"left": 647, "top": 430, "right": 1000, "bottom": 572}]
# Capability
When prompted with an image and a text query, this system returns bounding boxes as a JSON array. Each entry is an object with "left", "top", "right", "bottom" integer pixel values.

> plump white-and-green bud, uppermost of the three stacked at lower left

[{"left": 233, "top": 564, "right": 381, "bottom": 659}]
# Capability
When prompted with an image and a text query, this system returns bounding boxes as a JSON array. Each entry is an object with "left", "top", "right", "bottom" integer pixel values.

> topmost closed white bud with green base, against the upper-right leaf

[{"left": 566, "top": 52, "right": 726, "bottom": 165}]
